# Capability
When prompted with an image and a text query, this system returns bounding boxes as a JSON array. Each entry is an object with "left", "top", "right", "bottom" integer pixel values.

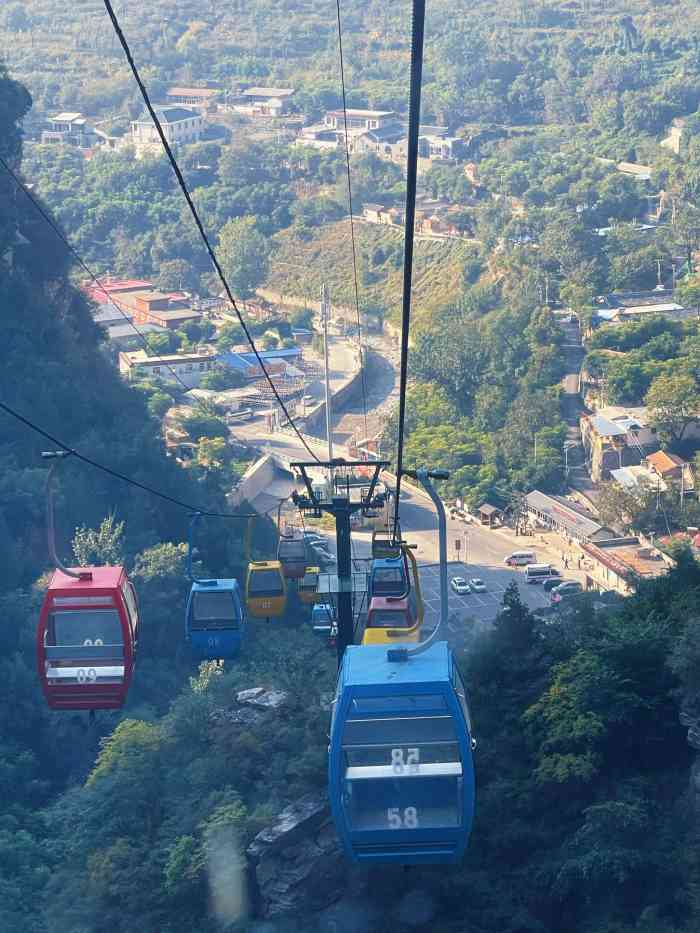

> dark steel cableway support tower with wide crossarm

[{"left": 290, "top": 460, "right": 389, "bottom": 667}]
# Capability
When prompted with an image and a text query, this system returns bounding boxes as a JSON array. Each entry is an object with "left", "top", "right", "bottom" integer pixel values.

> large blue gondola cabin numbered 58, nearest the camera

[{"left": 328, "top": 642, "right": 474, "bottom": 864}]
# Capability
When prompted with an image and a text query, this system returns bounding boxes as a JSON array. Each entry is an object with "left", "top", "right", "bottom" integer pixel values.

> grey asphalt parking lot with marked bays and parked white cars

[{"left": 420, "top": 561, "right": 549, "bottom": 631}]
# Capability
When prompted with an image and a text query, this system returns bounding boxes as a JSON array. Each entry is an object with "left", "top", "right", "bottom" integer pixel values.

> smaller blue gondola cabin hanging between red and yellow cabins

[{"left": 185, "top": 580, "right": 245, "bottom": 661}]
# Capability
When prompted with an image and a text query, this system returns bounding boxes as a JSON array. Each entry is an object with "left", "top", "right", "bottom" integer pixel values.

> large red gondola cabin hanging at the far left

[{"left": 36, "top": 567, "right": 138, "bottom": 710}]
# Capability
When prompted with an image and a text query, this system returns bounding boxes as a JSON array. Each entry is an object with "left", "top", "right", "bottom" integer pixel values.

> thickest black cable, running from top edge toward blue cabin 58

[{"left": 394, "top": 0, "right": 425, "bottom": 528}]
